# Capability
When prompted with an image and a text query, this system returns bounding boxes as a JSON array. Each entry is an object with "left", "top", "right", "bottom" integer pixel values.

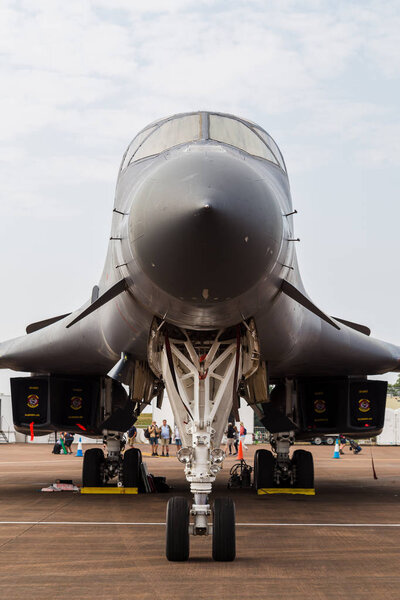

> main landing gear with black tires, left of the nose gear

[{"left": 82, "top": 433, "right": 142, "bottom": 487}]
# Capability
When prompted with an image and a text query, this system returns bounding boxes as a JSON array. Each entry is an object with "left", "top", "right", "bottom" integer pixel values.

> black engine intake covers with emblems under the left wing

[{"left": 11, "top": 375, "right": 134, "bottom": 437}]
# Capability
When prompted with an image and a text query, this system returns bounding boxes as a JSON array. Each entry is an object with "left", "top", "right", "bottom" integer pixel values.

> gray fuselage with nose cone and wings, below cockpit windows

[{"left": 0, "top": 113, "right": 400, "bottom": 378}]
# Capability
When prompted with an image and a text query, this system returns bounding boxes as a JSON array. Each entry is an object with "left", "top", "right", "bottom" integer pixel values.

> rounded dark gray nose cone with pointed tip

[{"left": 129, "top": 152, "right": 282, "bottom": 304}]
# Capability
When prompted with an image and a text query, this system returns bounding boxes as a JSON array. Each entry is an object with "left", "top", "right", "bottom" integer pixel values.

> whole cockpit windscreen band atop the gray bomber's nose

[{"left": 121, "top": 112, "right": 286, "bottom": 172}]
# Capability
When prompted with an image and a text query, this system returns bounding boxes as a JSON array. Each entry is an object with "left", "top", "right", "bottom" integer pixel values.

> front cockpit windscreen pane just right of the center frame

[{"left": 210, "top": 115, "right": 279, "bottom": 164}]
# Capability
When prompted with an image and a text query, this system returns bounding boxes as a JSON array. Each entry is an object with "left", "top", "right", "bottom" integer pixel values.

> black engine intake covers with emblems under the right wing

[{"left": 297, "top": 378, "right": 387, "bottom": 437}]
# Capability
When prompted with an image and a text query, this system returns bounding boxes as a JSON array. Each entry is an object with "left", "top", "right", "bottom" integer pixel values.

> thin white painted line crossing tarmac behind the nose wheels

[{"left": 0, "top": 521, "right": 400, "bottom": 527}]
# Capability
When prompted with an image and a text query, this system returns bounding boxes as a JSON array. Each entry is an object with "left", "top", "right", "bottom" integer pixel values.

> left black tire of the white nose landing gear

[{"left": 166, "top": 496, "right": 189, "bottom": 562}]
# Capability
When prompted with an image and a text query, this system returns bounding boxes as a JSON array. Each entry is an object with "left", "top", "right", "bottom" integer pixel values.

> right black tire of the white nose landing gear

[{"left": 212, "top": 497, "right": 236, "bottom": 562}]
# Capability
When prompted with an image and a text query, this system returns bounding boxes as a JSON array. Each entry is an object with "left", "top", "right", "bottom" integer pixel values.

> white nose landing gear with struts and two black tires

[{"left": 148, "top": 321, "right": 259, "bottom": 561}]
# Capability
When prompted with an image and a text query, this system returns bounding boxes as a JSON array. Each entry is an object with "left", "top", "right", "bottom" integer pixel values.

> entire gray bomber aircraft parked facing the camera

[{"left": 0, "top": 111, "right": 400, "bottom": 561}]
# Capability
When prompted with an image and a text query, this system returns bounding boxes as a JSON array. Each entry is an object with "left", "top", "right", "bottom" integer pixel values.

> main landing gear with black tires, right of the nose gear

[{"left": 254, "top": 431, "right": 314, "bottom": 490}]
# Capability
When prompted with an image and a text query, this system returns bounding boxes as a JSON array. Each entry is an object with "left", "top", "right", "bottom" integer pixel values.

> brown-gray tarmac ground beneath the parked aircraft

[{"left": 0, "top": 444, "right": 400, "bottom": 600}]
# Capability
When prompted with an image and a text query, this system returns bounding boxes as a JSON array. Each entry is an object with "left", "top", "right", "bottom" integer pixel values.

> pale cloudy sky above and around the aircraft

[{"left": 0, "top": 0, "right": 400, "bottom": 393}]
